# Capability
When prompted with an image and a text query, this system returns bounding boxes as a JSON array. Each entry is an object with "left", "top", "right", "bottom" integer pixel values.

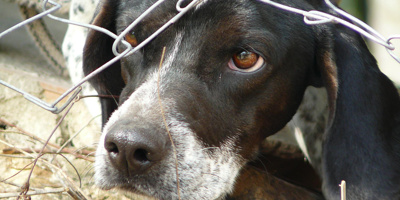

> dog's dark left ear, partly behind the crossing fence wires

[{"left": 83, "top": 0, "right": 125, "bottom": 125}]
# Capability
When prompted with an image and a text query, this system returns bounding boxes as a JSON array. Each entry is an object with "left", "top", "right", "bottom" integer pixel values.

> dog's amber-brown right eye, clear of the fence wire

[{"left": 228, "top": 51, "right": 264, "bottom": 72}]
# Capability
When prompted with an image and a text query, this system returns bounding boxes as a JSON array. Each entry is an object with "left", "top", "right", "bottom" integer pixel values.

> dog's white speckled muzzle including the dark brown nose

[{"left": 95, "top": 75, "right": 244, "bottom": 199}]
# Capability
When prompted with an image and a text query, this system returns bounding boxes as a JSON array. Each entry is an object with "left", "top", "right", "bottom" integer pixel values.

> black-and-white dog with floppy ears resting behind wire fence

[{"left": 83, "top": 0, "right": 400, "bottom": 199}]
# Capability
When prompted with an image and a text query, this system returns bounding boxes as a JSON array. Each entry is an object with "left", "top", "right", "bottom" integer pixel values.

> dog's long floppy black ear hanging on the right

[{"left": 318, "top": 19, "right": 400, "bottom": 199}]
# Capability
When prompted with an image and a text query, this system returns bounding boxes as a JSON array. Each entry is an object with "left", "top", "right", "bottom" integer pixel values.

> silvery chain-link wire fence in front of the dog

[{"left": 0, "top": 0, "right": 400, "bottom": 198}]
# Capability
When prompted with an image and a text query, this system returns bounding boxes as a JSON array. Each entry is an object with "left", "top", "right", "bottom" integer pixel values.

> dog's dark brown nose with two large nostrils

[{"left": 104, "top": 123, "right": 167, "bottom": 175}]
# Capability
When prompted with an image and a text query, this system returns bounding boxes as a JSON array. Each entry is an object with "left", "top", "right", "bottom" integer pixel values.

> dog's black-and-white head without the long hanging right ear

[{"left": 84, "top": 0, "right": 376, "bottom": 199}]
